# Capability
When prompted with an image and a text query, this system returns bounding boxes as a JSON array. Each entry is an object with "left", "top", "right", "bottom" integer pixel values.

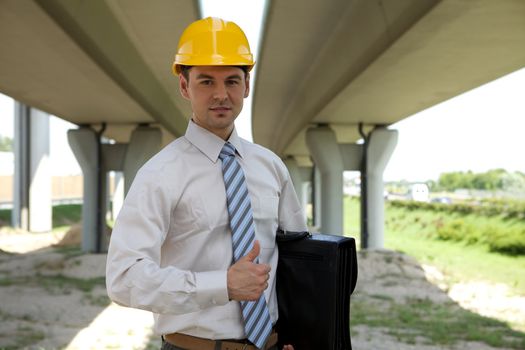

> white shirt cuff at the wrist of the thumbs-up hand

[{"left": 195, "top": 271, "right": 229, "bottom": 309}]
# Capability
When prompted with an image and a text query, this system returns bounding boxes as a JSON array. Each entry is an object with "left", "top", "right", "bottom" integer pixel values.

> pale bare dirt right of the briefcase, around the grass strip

[{"left": 350, "top": 250, "right": 525, "bottom": 350}]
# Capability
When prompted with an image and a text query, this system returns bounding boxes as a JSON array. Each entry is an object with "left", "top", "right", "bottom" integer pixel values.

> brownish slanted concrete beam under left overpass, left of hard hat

[{"left": 36, "top": 0, "right": 188, "bottom": 136}]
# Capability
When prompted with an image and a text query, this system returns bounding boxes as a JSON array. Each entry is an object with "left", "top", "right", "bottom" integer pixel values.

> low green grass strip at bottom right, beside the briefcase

[{"left": 350, "top": 296, "right": 525, "bottom": 349}]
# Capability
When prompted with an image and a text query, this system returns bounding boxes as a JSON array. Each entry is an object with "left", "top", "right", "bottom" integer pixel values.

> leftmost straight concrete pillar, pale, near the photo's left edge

[{"left": 12, "top": 102, "right": 52, "bottom": 232}]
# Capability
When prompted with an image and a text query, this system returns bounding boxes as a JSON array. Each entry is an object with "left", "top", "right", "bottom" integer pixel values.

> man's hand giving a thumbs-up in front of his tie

[{"left": 228, "top": 241, "right": 270, "bottom": 300}]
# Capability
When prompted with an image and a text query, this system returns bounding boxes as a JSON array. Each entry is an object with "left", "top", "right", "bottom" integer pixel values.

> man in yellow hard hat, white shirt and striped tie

[{"left": 106, "top": 18, "right": 306, "bottom": 350}]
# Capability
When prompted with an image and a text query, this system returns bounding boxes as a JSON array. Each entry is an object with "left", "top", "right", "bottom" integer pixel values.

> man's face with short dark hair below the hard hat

[{"left": 179, "top": 66, "right": 250, "bottom": 140}]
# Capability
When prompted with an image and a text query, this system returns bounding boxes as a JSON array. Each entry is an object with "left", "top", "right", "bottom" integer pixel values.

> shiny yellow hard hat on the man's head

[{"left": 172, "top": 17, "right": 255, "bottom": 75}]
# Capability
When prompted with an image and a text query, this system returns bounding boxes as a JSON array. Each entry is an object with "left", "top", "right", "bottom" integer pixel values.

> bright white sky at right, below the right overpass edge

[{"left": 384, "top": 68, "right": 525, "bottom": 181}]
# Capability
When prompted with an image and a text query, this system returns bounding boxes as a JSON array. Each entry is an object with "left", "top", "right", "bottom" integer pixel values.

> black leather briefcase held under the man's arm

[{"left": 276, "top": 230, "right": 357, "bottom": 350}]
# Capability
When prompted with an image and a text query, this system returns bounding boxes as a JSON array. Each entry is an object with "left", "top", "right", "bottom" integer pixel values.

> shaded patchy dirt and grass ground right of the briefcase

[{"left": 351, "top": 251, "right": 525, "bottom": 350}]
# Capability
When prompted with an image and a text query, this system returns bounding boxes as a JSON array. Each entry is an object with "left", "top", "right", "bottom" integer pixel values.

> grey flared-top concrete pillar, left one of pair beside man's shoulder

[{"left": 67, "top": 127, "right": 100, "bottom": 252}]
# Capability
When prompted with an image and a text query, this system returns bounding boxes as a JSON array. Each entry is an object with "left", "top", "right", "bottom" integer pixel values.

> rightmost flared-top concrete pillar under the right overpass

[{"left": 366, "top": 128, "right": 398, "bottom": 249}]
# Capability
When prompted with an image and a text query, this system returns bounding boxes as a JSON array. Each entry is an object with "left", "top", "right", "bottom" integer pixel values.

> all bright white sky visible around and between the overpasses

[{"left": 0, "top": 0, "right": 525, "bottom": 182}]
